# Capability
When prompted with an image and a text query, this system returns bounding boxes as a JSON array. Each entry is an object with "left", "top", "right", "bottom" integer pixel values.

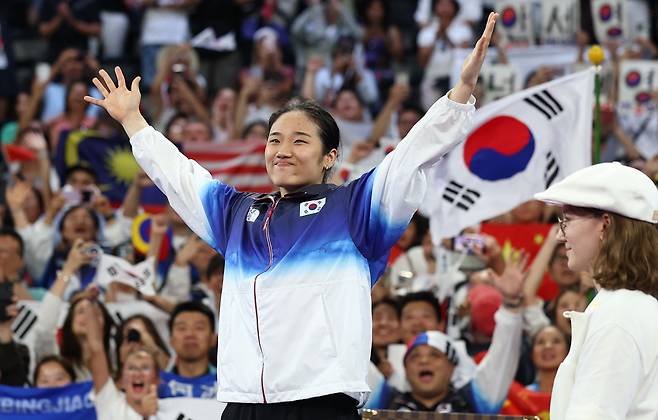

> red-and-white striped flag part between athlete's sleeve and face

[{"left": 183, "top": 141, "right": 274, "bottom": 193}]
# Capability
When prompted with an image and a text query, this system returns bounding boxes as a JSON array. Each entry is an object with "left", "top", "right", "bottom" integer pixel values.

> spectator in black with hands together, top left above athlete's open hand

[{"left": 39, "top": 0, "right": 101, "bottom": 62}]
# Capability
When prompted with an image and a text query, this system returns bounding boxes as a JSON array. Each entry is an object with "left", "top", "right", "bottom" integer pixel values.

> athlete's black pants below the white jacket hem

[{"left": 222, "top": 394, "right": 361, "bottom": 420}]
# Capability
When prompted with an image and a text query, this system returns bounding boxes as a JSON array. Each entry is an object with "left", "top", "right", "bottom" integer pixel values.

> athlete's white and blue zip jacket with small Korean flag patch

[{"left": 130, "top": 93, "right": 475, "bottom": 403}]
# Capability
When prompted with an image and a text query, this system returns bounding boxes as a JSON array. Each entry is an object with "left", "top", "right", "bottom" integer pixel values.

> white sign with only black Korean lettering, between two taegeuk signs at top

[{"left": 541, "top": 0, "right": 580, "bottom": 44}]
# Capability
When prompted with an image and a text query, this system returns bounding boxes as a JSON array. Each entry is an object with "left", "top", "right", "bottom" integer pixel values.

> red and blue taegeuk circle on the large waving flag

[{"left": 464, "top": 115, "right": 535, "bottom": 181}]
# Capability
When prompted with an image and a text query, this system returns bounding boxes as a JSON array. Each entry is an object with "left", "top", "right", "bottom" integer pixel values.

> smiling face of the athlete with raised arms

[{"left": 265, "top": 111, "right": 338, "bottom": 195}]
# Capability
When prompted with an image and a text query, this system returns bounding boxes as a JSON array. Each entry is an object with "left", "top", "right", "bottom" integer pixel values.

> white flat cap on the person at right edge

[{"left": 535, "top": 162, "right": 658, "bottom": 223}]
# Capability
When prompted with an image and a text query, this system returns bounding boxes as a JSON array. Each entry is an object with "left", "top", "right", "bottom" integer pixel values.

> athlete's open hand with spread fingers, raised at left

[{"left": 84, "top": 66, "right": 142, "bottom": 125}]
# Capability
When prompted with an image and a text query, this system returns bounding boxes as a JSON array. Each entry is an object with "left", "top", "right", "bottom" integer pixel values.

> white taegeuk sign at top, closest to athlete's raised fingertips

[{"left": 496, "top": 0, "right": 534, "bottom": 46}]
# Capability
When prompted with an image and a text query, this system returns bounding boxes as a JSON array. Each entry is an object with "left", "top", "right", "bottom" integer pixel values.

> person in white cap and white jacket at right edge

[{"left": 535, "top": 163, "right": 658, "bottom": 420}]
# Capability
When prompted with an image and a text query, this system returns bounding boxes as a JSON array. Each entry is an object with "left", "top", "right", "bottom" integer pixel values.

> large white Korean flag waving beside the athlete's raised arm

[{"left": 421, "top": 69, "right": 594, "bottom": 241}]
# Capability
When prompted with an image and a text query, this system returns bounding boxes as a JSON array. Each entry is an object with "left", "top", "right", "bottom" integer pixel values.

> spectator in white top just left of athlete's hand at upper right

[{"left": 417, "top": 0, "right": 473, "bottom": 109}]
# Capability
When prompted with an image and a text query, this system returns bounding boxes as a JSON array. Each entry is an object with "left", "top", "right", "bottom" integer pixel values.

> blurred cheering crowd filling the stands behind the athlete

[{"left": 0, "top": 0, "right": 658, "bottom": 419}]
